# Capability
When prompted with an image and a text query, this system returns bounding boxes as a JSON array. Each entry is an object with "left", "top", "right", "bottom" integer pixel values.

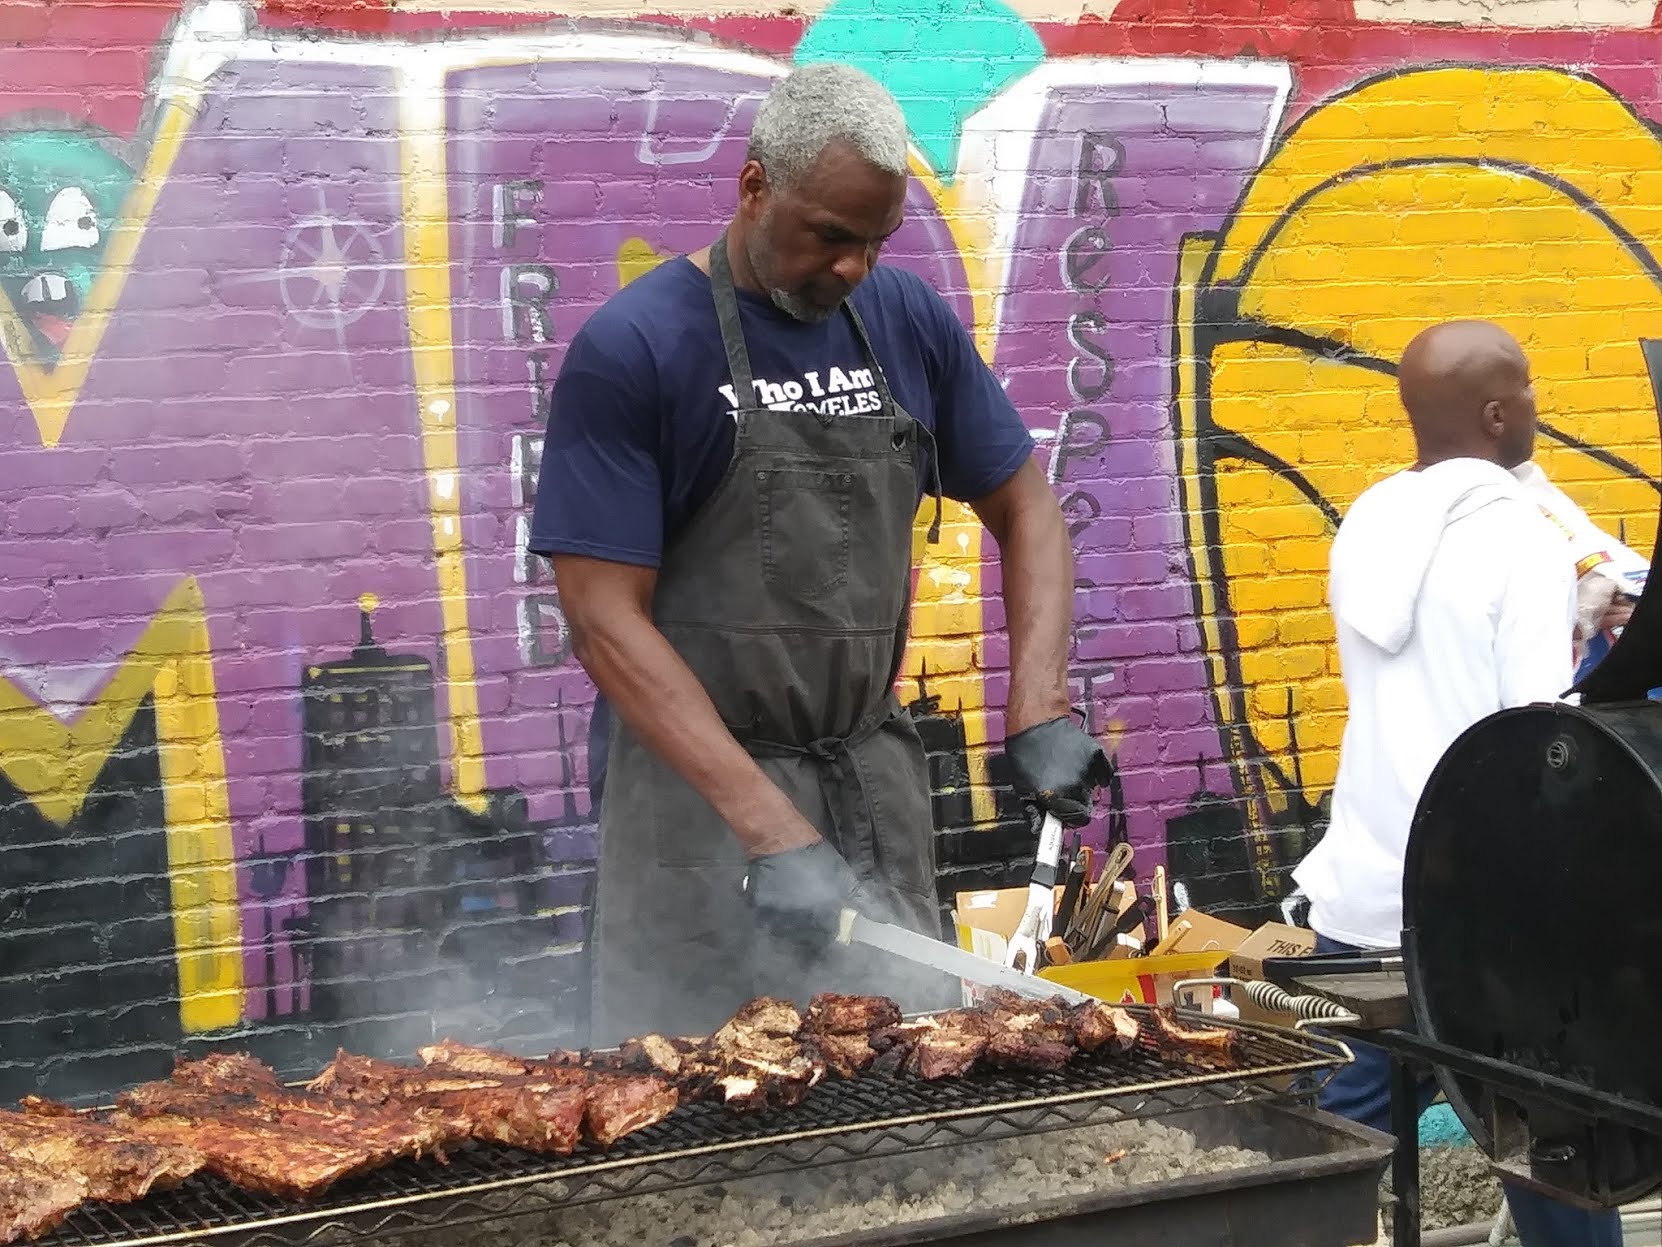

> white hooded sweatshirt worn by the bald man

[{"left": 1293, "top": 459, "right": 1576, "bottom": 948}]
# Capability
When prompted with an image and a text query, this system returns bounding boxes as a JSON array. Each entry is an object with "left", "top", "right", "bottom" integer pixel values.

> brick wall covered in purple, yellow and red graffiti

[{"left": 0, "top": 0, "right": 1662, "bottom": 1099}]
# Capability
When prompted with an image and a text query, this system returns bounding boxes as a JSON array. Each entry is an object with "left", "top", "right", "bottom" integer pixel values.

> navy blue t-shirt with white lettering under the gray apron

[{"left": 530, "top": 256, "right": 1032, "bottom": 567}]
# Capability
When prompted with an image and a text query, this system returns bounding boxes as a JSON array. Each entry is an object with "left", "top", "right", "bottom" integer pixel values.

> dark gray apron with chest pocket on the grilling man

[{"left": 590, "top": 234, "right": 956, "bottom": 1046}]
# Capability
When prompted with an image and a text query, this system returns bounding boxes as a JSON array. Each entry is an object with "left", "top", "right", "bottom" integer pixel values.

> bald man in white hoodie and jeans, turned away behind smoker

[{"left": 1293, "top": 321, "right": 1620, "bottom": 1247}]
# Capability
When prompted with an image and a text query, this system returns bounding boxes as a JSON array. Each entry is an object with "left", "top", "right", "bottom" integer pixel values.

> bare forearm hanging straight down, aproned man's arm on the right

[{"left": 999, "top": 485, "right": 1074, "bottom": 735}]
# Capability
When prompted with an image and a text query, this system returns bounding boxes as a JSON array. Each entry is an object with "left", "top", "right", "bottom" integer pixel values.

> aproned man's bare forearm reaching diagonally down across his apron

[{"left": 573, "top": 615, "right": 818, "bottom": 856}]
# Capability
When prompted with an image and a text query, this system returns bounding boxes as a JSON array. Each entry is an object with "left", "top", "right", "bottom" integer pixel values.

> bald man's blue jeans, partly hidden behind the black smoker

[{"left": 1316, "top": 934, "right": 1622, "bottom": 1247}]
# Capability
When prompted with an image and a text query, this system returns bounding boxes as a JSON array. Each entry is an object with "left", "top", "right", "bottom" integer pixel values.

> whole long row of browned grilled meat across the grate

[{"left": 0, "top": 991, "right": 1238, "bottom": 1245}]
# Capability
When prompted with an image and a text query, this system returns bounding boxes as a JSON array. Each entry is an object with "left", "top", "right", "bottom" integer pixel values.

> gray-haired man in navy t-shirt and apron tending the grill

[{"left": 530, "top": 65, "right": 1107, "bottom": 1044}]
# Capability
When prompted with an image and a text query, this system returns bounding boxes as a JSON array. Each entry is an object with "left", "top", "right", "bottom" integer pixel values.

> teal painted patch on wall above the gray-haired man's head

[{"left": 796, "top": 0, "right": 1044, "bottom": 181}]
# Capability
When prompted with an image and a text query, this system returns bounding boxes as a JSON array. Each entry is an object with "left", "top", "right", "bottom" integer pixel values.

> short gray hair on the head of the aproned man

[{"left": 746, "top": 62, "right": 907, "bottom": 190}]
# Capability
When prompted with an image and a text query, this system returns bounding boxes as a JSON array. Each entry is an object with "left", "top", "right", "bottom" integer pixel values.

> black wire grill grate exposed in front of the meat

[{"left": 25, "top": 1006, "right": 1348, "bottom": 1247}]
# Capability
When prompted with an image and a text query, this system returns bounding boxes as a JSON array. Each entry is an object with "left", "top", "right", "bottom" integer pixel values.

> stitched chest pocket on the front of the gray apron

[{"left": 756, "top": 467, "right": 854, "bottom": 599}]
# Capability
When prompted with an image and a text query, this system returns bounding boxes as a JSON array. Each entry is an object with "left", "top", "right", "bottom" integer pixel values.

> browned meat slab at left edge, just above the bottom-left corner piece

[{"left": 0, "top": 1111, "right": 208, "bottom": 1204}]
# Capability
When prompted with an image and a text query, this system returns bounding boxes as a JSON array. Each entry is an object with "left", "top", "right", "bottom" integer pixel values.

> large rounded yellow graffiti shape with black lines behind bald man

[{"left": 1178, "top": 67, "right": 1662, "bottom": 884}]
